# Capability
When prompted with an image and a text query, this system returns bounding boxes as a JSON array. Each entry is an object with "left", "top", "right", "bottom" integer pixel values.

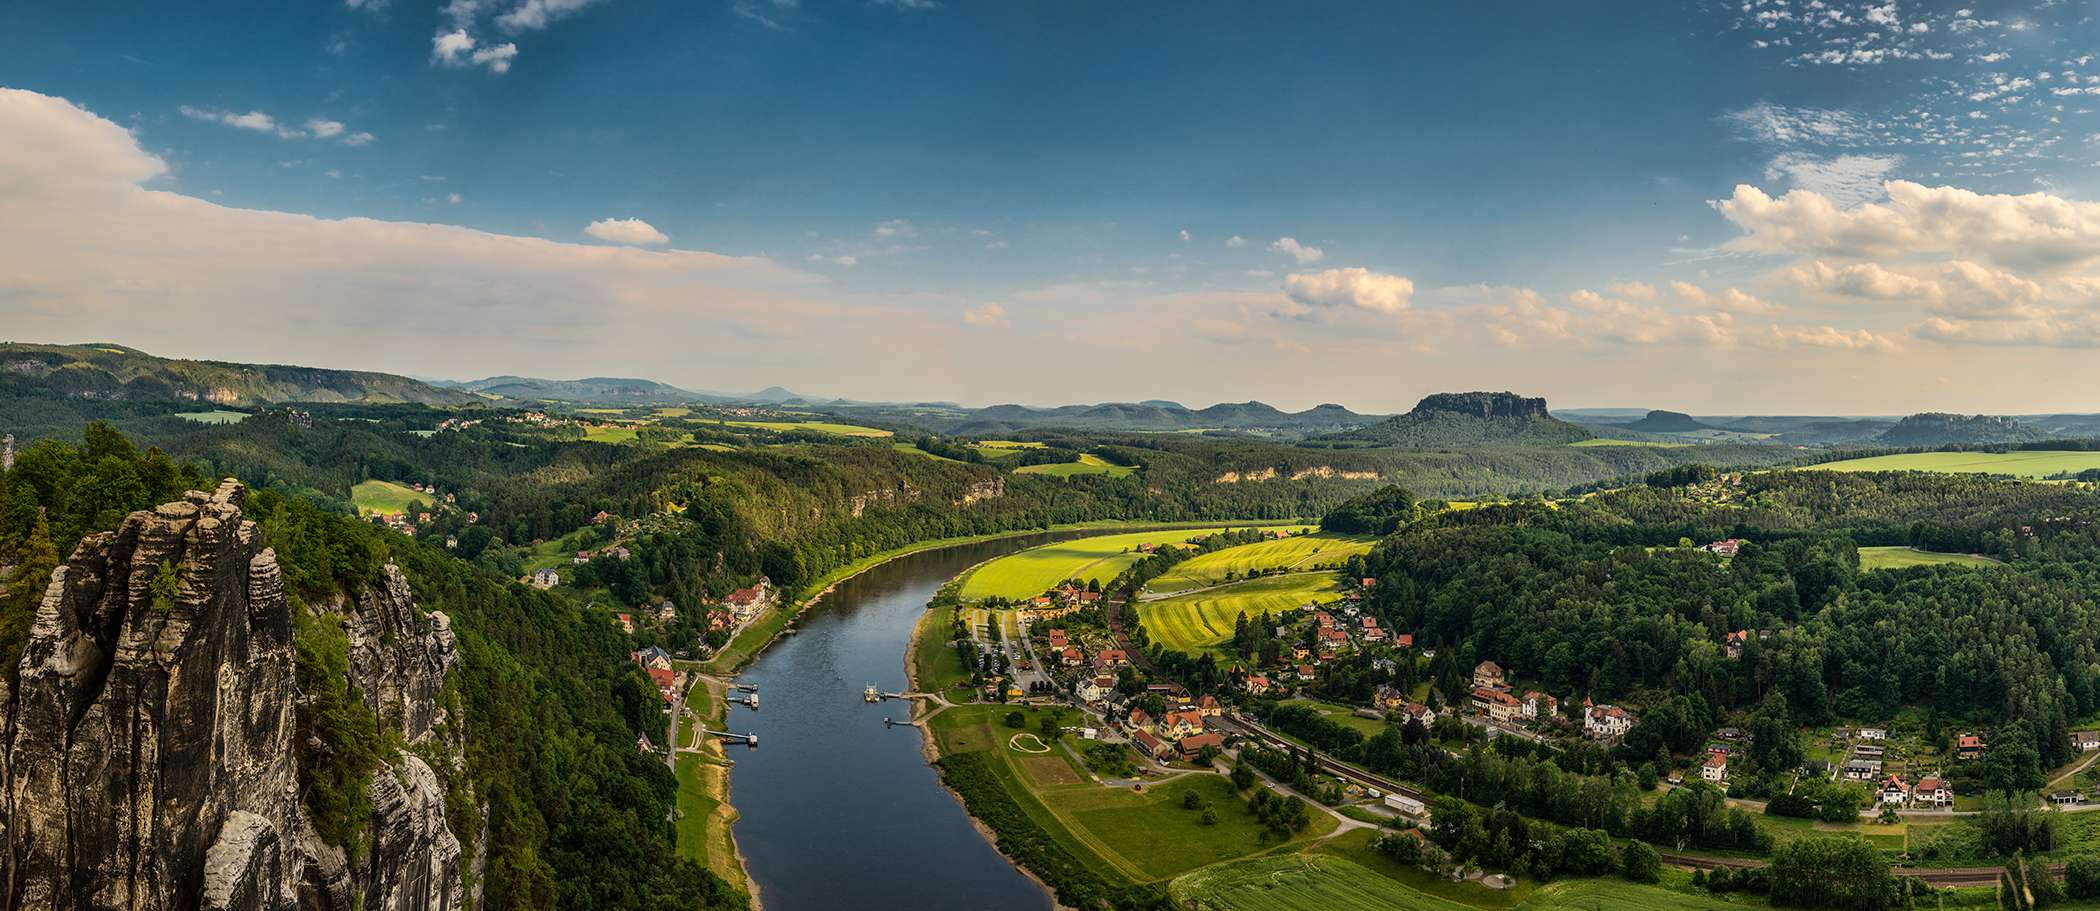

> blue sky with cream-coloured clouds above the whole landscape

[{"left": 0, "top": 0, "right": 2100, "bottom": 414}]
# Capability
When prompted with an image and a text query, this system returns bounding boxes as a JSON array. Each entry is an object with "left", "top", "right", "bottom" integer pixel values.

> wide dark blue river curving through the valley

[{"left": 729, "top": 533, "right": 1073, "bottom": 911}]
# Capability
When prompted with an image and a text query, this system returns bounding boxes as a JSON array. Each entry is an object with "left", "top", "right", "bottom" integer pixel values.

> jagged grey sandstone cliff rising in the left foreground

[{"left": 0, "top": 481, "right": 460, "bottom": 911}]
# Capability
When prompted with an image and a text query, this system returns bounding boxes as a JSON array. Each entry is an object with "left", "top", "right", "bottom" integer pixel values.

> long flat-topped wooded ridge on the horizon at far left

[{"left": 0, "top": 342, "right": 485, "bottom": 407}]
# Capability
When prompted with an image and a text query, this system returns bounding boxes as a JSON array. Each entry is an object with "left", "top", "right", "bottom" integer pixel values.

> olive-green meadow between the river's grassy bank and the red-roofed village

[{"left": 930, "top": 705, "right": 1336, "bottom": 882}]
